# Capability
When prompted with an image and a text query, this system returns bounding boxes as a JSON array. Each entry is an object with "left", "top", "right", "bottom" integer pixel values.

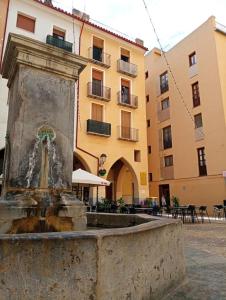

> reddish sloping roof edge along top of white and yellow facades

[{"left": 33, "top": 0, "right": 148, "bottom": 51}]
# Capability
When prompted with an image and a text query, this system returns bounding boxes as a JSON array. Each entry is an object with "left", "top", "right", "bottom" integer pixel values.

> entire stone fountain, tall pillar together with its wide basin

[{"left": 0, "top": 34, "right": 185, "bottom": 300}]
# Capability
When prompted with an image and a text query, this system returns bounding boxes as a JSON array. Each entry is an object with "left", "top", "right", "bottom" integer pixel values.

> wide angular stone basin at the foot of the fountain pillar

[{"left": 0, "top": 213, "right": 185, "bottom": 300}]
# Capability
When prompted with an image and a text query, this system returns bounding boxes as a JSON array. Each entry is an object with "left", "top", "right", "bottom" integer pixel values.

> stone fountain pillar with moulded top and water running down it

[{"left": 0, "top": 34, "right": 87, "bottom": 232}]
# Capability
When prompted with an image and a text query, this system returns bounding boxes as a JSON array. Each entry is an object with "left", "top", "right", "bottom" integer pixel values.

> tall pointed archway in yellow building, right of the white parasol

[{"left": 106, "top": 158, "right": 139, "bottom": 204}]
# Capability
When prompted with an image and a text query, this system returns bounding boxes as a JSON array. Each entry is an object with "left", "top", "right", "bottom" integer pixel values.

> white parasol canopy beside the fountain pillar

[{"left": 72, "top": 169, "right": 110, "bottom": 186}]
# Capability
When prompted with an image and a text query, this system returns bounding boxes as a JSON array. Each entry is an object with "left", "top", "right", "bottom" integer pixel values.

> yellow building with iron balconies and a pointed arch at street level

[{"left": 75, "top": 12, "right": 149, "bottom": 203}]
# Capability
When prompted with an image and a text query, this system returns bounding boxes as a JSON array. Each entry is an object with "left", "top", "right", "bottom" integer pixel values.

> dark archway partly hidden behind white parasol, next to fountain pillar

[{"left": 72, "top": 152, "right": 93, "bottom": 203}]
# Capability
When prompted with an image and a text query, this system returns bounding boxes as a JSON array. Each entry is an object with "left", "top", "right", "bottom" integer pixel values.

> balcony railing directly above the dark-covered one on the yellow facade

[{"left": 87, "top": 82, "right": 111, "bottom": 101}]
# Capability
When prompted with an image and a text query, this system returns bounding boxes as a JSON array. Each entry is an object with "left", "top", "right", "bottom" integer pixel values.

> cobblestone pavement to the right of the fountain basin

[{"left": 164, "top": 223, "right": 226, "bottom": 300}]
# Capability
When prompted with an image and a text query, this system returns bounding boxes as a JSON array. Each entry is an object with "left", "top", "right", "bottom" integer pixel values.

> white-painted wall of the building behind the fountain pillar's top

[{"left": 0, "top": 0, "right": 81, "bottom": 149}]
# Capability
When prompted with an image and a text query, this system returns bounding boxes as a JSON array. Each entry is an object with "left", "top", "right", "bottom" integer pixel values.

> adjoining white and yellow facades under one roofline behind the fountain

[{"left": 0, "top": 0, "right": 148, "bottom": 203}]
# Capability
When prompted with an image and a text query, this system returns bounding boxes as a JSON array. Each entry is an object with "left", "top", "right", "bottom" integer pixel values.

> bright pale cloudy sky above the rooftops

[{"left": 53, "top": 0, "right": 226, "bottom": 50}]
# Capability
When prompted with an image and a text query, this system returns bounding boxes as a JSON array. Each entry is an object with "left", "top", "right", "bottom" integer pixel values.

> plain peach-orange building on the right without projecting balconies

[{"left": 145, "top": 17, "right": 226, "bottom": 211}]
